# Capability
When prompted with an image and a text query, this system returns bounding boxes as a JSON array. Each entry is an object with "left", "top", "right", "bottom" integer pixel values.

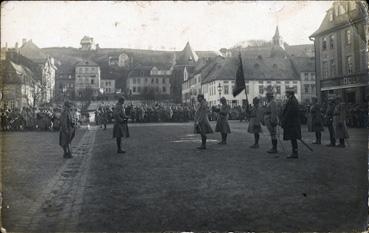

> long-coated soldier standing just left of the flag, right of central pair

[{"left": 215, "top": 97, "right": 231, "bottom": 145}]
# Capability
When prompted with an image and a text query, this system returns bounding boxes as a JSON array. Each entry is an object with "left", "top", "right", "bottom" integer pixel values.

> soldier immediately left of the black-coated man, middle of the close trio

[{"left": 264, "top": 91, "right": 278, "bottom": 154}]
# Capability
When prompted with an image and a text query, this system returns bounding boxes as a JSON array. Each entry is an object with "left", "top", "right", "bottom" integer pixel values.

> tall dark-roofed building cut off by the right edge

[{"left": 310, "top": 1, "right": 368, "bottom": 103}]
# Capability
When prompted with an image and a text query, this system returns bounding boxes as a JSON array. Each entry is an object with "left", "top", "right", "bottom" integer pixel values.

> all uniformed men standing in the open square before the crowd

[{"left": 59, "top": 88, "right": 349, "bottom": 158}]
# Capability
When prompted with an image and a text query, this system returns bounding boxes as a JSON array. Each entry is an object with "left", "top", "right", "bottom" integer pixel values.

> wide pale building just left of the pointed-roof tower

[{"left": 126, "top": 66, "right": 172, "bottom": 100}]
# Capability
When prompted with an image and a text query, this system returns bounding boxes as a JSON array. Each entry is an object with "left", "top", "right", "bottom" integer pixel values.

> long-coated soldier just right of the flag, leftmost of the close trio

[{"left": 247, "top": 97, "right": 263, "bottom": 148}]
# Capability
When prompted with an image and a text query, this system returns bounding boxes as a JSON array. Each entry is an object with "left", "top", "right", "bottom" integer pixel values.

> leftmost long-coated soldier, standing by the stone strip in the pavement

[{"left": 59, "top": 101, "right": 76, "bottom": 158}]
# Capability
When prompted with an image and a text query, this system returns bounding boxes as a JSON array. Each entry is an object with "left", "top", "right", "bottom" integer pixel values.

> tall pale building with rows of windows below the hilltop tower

[{"left": 74, "top": 60, "right": 101, "bottom": 97}]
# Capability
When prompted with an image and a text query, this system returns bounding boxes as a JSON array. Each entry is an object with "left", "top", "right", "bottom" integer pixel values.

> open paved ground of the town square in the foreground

[{"left": 0, "top": 122, "right": 368, "bottom": 232}]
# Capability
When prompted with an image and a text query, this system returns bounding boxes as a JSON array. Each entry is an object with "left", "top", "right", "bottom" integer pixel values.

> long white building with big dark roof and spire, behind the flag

[{"left": 202, "top": 28, "right": 301, "bottom": 105}]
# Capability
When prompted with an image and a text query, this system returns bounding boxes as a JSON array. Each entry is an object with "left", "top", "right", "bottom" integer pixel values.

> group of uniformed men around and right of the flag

[{"left": 191, "top": 88, "right": 349, "bottom": 158}]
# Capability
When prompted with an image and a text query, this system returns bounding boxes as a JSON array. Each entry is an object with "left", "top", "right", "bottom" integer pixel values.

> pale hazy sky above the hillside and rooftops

[{"left": 1, "top": 1, "right": 332, "bottom": 50}]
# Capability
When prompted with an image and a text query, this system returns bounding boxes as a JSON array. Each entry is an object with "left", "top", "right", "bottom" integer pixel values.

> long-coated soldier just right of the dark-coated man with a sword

[{"left": 309, "top": 97, "right": 324, "bottom": 145}]
